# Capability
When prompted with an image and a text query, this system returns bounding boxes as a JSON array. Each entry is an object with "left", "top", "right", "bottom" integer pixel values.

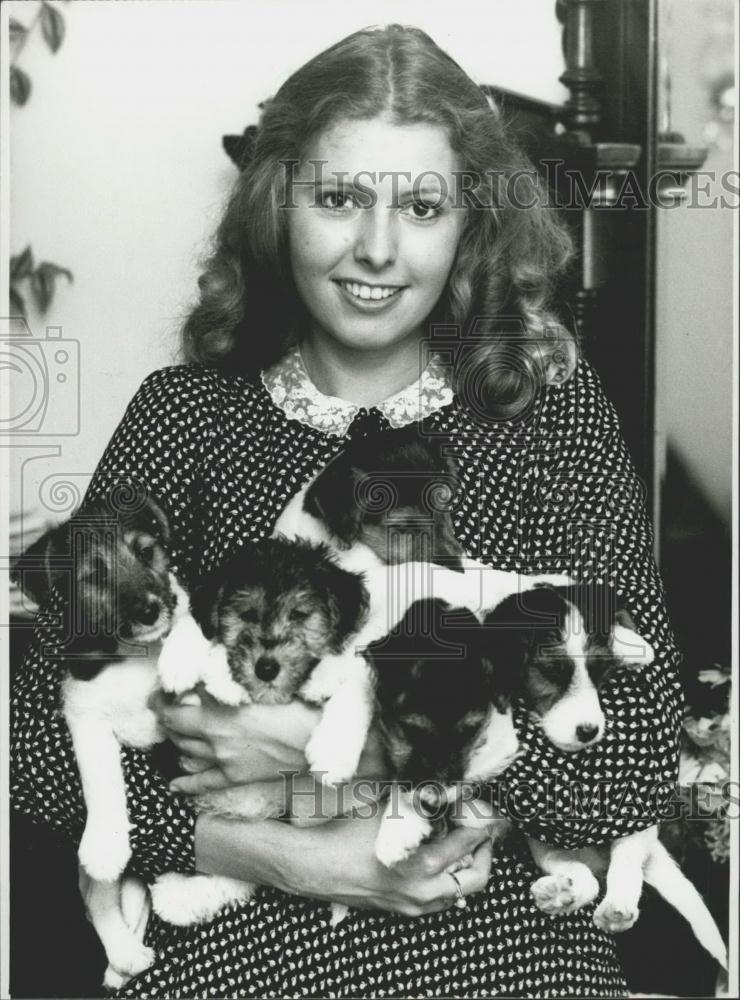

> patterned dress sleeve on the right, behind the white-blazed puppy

[{"left": 499, "top": 362, "right": 683, "bottom": 848}]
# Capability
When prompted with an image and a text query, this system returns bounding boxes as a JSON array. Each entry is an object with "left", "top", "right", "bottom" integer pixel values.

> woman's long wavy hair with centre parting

[{"left": 183, "top": 24, "right": 576, "bottom": 416}]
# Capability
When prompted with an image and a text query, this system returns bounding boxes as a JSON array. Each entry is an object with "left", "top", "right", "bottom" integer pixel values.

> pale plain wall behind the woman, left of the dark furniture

[{"left": 6, "top": 0, "right": 566, "bottom": 540}]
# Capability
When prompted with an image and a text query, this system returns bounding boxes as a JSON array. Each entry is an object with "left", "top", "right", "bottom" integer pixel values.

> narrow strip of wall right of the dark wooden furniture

[{"left": 656, "top": 0, "right": 737, "bottom": 532}]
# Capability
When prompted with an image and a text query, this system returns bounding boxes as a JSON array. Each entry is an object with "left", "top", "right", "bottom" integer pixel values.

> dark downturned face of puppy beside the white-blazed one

[{"left": 368, "top": 600, "right": 492, "bottom": 784}]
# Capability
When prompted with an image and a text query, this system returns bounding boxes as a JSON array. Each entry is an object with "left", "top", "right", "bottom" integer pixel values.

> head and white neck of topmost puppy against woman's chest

[{"left": 275, "top": 425, "right": 464, "bottom": 569}]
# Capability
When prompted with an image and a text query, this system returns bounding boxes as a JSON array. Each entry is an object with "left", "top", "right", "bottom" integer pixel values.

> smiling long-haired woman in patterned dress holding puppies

[{"left": 14, "top": 26, "right": 680, "bottom": 997}]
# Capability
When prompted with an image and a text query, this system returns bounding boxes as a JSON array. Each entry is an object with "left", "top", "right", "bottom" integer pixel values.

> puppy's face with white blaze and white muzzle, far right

[{"left": 484, "top": 587, "right": 652, "bottom": 752}]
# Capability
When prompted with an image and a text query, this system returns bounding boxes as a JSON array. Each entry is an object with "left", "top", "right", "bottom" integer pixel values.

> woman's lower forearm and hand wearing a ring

[{"left": 196, "top": 807, "right": 491, "bottom": 916}]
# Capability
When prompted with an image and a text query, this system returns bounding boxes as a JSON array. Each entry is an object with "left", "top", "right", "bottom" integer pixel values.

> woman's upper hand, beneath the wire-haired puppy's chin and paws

[{"left": 152, "top": 690, "right": 390, "bottom": 795}]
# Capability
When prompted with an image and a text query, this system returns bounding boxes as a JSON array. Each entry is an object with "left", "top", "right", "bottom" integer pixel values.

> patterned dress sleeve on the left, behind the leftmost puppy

[{"left": 11, "top": 367, "right": 215, "bottom": 878}]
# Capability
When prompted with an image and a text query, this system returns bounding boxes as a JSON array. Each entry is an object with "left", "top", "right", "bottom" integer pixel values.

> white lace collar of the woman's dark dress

[{"left": 262, "top": 347, "right": 453, "bottom": 437}]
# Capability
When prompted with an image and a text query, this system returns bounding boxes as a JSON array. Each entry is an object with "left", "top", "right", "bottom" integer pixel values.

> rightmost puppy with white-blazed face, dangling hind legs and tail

[{"left": 485, "top": 586, "right": 727, "bottom": 968}]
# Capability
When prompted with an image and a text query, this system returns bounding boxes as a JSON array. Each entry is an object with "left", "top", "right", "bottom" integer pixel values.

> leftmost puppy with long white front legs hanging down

[{"left": 14, "top": 493, "right": 187, "bottom": 982}]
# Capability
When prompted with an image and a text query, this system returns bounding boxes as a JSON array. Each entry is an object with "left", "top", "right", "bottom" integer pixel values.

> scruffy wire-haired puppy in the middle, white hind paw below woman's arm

[{"left": 151, "top": 538, "right": 372, "bottom": 925}]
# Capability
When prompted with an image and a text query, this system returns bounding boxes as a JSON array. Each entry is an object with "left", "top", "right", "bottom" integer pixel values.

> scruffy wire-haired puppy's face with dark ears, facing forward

[{"left": 193, "top": 538, "right": 367, "bottom": 705}]
